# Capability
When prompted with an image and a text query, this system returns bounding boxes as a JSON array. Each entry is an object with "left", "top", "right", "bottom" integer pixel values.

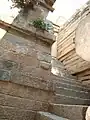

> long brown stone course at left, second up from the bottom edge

[{"left": 0, "top": 94, "right": 48, "bottom": 111}]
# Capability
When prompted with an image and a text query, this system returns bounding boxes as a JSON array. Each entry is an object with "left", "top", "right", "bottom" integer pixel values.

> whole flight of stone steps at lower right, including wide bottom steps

[{"left": 35, "top": 77, "right": 90, "bottom": 120}]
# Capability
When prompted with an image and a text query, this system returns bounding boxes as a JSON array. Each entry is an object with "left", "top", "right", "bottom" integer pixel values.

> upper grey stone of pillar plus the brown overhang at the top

[{"left": 13, "top": 0, "right": 56, "bottom": 28}]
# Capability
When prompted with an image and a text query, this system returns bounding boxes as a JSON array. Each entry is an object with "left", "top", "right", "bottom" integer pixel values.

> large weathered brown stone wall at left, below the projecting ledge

[{"left": 0, "top": 25, "right": 54, "bottom": 120}]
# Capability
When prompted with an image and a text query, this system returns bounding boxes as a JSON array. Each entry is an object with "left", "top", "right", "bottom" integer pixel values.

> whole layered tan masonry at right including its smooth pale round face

[{"left": 57, "top": 0, "right": 90, "bottom": 86}]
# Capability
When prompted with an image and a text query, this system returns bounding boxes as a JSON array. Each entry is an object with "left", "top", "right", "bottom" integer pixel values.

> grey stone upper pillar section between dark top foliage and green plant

[{"left": 13, "top": 0, "right": 49, "bottom": 28}]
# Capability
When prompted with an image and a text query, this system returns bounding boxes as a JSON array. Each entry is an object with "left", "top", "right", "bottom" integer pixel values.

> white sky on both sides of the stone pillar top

[{"left": 0, "top": 0, "right": 87, "bottom": 23}]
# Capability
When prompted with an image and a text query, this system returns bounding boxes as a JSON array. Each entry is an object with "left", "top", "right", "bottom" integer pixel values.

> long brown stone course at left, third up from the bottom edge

[{"left": 0, "top": 81, "right": 54, "bottom": 102}]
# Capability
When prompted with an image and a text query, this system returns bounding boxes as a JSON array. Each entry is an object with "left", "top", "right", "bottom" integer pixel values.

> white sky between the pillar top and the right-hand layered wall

[{"left": 48, "top": 0, "right": 88, "bottom": 24}]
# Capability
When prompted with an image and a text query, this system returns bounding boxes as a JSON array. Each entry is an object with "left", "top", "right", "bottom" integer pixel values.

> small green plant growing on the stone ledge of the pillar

[{"left": 31, "top": 18, "right": 53, "bottom": 31}]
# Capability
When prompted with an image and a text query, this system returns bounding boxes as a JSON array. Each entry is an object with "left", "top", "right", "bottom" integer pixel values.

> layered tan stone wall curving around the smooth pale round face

[{"left": 57, "top": 2, "right": 90, "bottom": 81}]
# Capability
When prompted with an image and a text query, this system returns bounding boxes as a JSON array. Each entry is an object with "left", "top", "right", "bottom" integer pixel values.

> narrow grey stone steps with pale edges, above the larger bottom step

[{"left": 55, "top": 79, "right": 90, "bottom": 105}]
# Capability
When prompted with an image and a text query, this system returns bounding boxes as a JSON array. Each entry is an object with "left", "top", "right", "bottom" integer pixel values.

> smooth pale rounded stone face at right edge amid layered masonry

[{"left": 75, "top": 15, "right": 90, "bottom": 61}]
